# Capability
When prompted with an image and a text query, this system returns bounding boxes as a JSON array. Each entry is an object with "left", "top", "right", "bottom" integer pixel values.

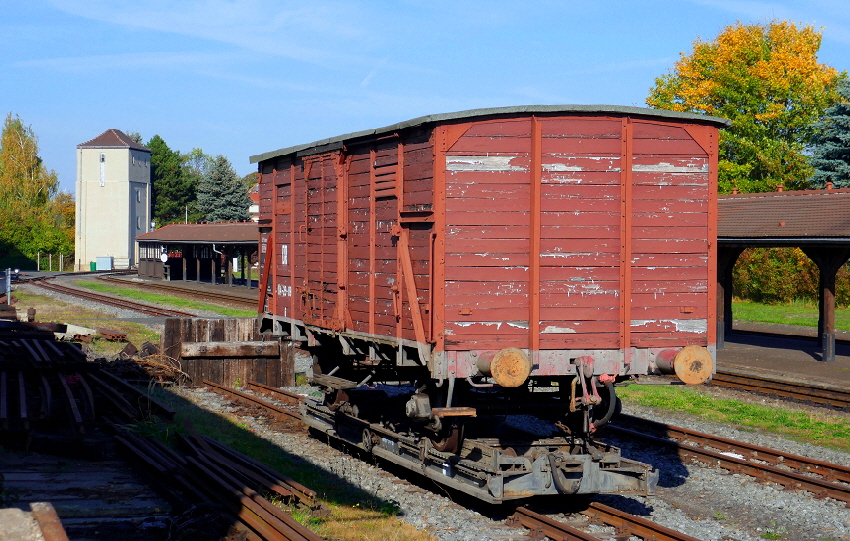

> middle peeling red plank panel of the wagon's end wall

[{"left": 538, "top": 117, "right": 623, "bottom": 350}]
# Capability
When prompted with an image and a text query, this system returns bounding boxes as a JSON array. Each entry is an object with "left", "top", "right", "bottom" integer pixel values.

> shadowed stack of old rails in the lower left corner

[{"left": 0, "top": 324, "right": 321, "bottom": 541}]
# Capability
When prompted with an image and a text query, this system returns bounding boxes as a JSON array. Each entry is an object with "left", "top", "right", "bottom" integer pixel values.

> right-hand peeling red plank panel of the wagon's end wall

[{"left": 631, "top": 121, "right": 716, "bottom": 347}]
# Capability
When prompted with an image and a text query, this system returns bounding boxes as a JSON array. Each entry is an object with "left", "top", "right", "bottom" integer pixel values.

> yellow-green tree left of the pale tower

[{"left": 0, "top": 113, "right": 74, "bottom": 266}]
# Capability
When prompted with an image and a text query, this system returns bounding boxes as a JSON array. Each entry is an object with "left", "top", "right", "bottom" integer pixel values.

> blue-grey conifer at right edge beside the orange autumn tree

[{"left": 811, "top": 78, "right": 850, "bottom": 188}]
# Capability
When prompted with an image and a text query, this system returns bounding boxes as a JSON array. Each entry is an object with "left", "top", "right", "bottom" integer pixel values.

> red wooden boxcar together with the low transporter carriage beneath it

[{"left": 251, "top": 105, "right": 728, "bottom": 502}]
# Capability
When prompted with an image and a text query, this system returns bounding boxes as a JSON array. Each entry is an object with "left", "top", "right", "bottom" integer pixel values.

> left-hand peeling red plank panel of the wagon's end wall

[{"left": 444, "top": 118, "right": 531, "bottom": 350}]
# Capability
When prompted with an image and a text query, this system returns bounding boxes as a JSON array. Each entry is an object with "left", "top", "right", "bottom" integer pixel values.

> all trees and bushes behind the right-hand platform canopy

[{"left": 646, "top": 21, "right": 850, "bottom": 306}]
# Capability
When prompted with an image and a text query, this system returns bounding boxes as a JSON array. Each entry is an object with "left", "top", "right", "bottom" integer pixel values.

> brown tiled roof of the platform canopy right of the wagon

[{"left": 717, "top": 189, "right": 850, "bottom": 242}]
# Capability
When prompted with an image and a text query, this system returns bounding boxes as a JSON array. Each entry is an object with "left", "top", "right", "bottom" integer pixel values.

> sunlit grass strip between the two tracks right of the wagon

[{"left": 617, "top": 385, "right": 850, "bottom": 452}]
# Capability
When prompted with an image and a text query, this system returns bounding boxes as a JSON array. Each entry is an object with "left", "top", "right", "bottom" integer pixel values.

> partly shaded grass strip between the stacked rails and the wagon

[{"left": 146, "top": 388, "right": 434, "bottom": 541}]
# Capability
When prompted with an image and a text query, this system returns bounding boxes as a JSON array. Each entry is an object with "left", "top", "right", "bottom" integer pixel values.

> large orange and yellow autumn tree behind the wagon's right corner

[{"left": 646, "top": 21, "right": 845, "bottom": 193}]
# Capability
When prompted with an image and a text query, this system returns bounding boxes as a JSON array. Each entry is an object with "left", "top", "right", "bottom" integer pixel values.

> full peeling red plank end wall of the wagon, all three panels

[{"left": 445, "top": 117, "right": 711, "bottom": 350}]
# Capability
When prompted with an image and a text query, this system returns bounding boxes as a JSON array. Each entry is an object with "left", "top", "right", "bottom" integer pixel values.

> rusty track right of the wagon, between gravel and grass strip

[{"left": 606, "top": 415, "right": 850, "bottom": 507}]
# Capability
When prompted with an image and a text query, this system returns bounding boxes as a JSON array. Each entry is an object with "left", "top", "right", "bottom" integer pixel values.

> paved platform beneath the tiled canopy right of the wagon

[{"left": 717, "top": 322, "right": 850, "bottom": 389}]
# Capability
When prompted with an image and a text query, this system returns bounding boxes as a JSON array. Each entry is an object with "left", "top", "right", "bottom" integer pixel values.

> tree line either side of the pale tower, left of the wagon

[{"left": 0, "top": 121, "right": 257, "bottom": 268}]
